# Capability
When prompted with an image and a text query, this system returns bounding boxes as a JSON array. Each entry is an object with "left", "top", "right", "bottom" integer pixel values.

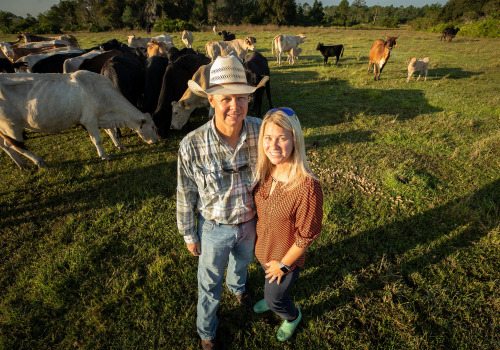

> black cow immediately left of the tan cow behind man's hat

[{"left": 153, "top": 54, "right": 211, "bottom": 138}]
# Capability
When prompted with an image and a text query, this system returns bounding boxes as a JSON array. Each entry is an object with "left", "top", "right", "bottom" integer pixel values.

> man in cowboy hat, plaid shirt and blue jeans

[{"left": 177, "top": 56, "right": 268, "bottom": 349}]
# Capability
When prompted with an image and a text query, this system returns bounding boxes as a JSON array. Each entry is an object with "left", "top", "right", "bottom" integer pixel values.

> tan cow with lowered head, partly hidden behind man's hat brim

[{"left": 170, "top": 63, "right": 215, "bottom": 130}]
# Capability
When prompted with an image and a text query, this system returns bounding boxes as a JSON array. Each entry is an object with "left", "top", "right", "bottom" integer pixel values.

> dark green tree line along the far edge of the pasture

[{"left": 0, "top": 0, "right": 500, "bottom": 33}]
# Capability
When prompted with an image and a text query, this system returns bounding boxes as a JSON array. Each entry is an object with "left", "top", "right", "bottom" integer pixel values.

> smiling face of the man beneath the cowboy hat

[{"left": 208, "top": 94, "right": 248, "bottom": 130}]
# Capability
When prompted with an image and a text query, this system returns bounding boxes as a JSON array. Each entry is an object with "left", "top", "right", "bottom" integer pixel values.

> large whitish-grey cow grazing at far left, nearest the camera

[{"left": 0, "top": 71, "right": 158, "bottom": 169}]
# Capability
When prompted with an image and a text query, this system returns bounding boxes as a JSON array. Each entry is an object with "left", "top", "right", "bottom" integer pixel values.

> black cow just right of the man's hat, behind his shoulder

[{"left": 243, "top": 52, "right": 273, "bottom": 118}]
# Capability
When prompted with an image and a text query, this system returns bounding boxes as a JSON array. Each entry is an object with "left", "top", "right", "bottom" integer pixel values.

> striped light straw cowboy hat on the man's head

[{"left": 188, "top": 55, "right": 269, "bottom": 97}]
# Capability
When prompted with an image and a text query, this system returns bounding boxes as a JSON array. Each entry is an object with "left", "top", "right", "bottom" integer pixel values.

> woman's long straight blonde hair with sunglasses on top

[{"left": 256, "top": 107, "right": 316, "bottom": 190}]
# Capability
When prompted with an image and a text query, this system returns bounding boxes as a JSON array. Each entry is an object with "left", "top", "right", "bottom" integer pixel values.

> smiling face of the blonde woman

[{"left": 263, "top": 122, "right": 294, "bottom": 166}]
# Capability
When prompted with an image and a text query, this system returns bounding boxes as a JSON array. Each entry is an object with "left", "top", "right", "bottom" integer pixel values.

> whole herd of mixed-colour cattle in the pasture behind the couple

[{"left": 0, "top": 27, "right": 456, "bottom": 168}]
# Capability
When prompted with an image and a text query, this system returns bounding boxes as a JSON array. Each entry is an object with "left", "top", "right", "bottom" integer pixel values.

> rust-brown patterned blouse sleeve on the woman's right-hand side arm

[{"left": 295, "top": 179, "right": 323, "bottom": 248}]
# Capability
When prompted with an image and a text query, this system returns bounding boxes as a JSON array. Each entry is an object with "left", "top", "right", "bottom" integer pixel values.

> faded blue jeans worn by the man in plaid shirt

[{"left": 196, "top": 215, "right": 257, "bottom": 340}]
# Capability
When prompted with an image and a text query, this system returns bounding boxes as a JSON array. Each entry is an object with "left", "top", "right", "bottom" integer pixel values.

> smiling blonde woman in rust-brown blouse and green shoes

[{"left": 253, "top": 108, "right": 323, "bottom": 341}]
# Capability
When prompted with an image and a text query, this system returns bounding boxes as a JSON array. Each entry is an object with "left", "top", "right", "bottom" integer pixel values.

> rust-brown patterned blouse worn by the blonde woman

[{"left": 254, "top": 176, "right": 323, "bottom": 269}]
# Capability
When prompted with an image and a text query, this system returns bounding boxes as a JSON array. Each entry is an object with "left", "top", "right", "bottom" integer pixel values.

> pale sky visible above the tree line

[{"left": 0, "top": 0, "right": 447, "bottom": 17}]
